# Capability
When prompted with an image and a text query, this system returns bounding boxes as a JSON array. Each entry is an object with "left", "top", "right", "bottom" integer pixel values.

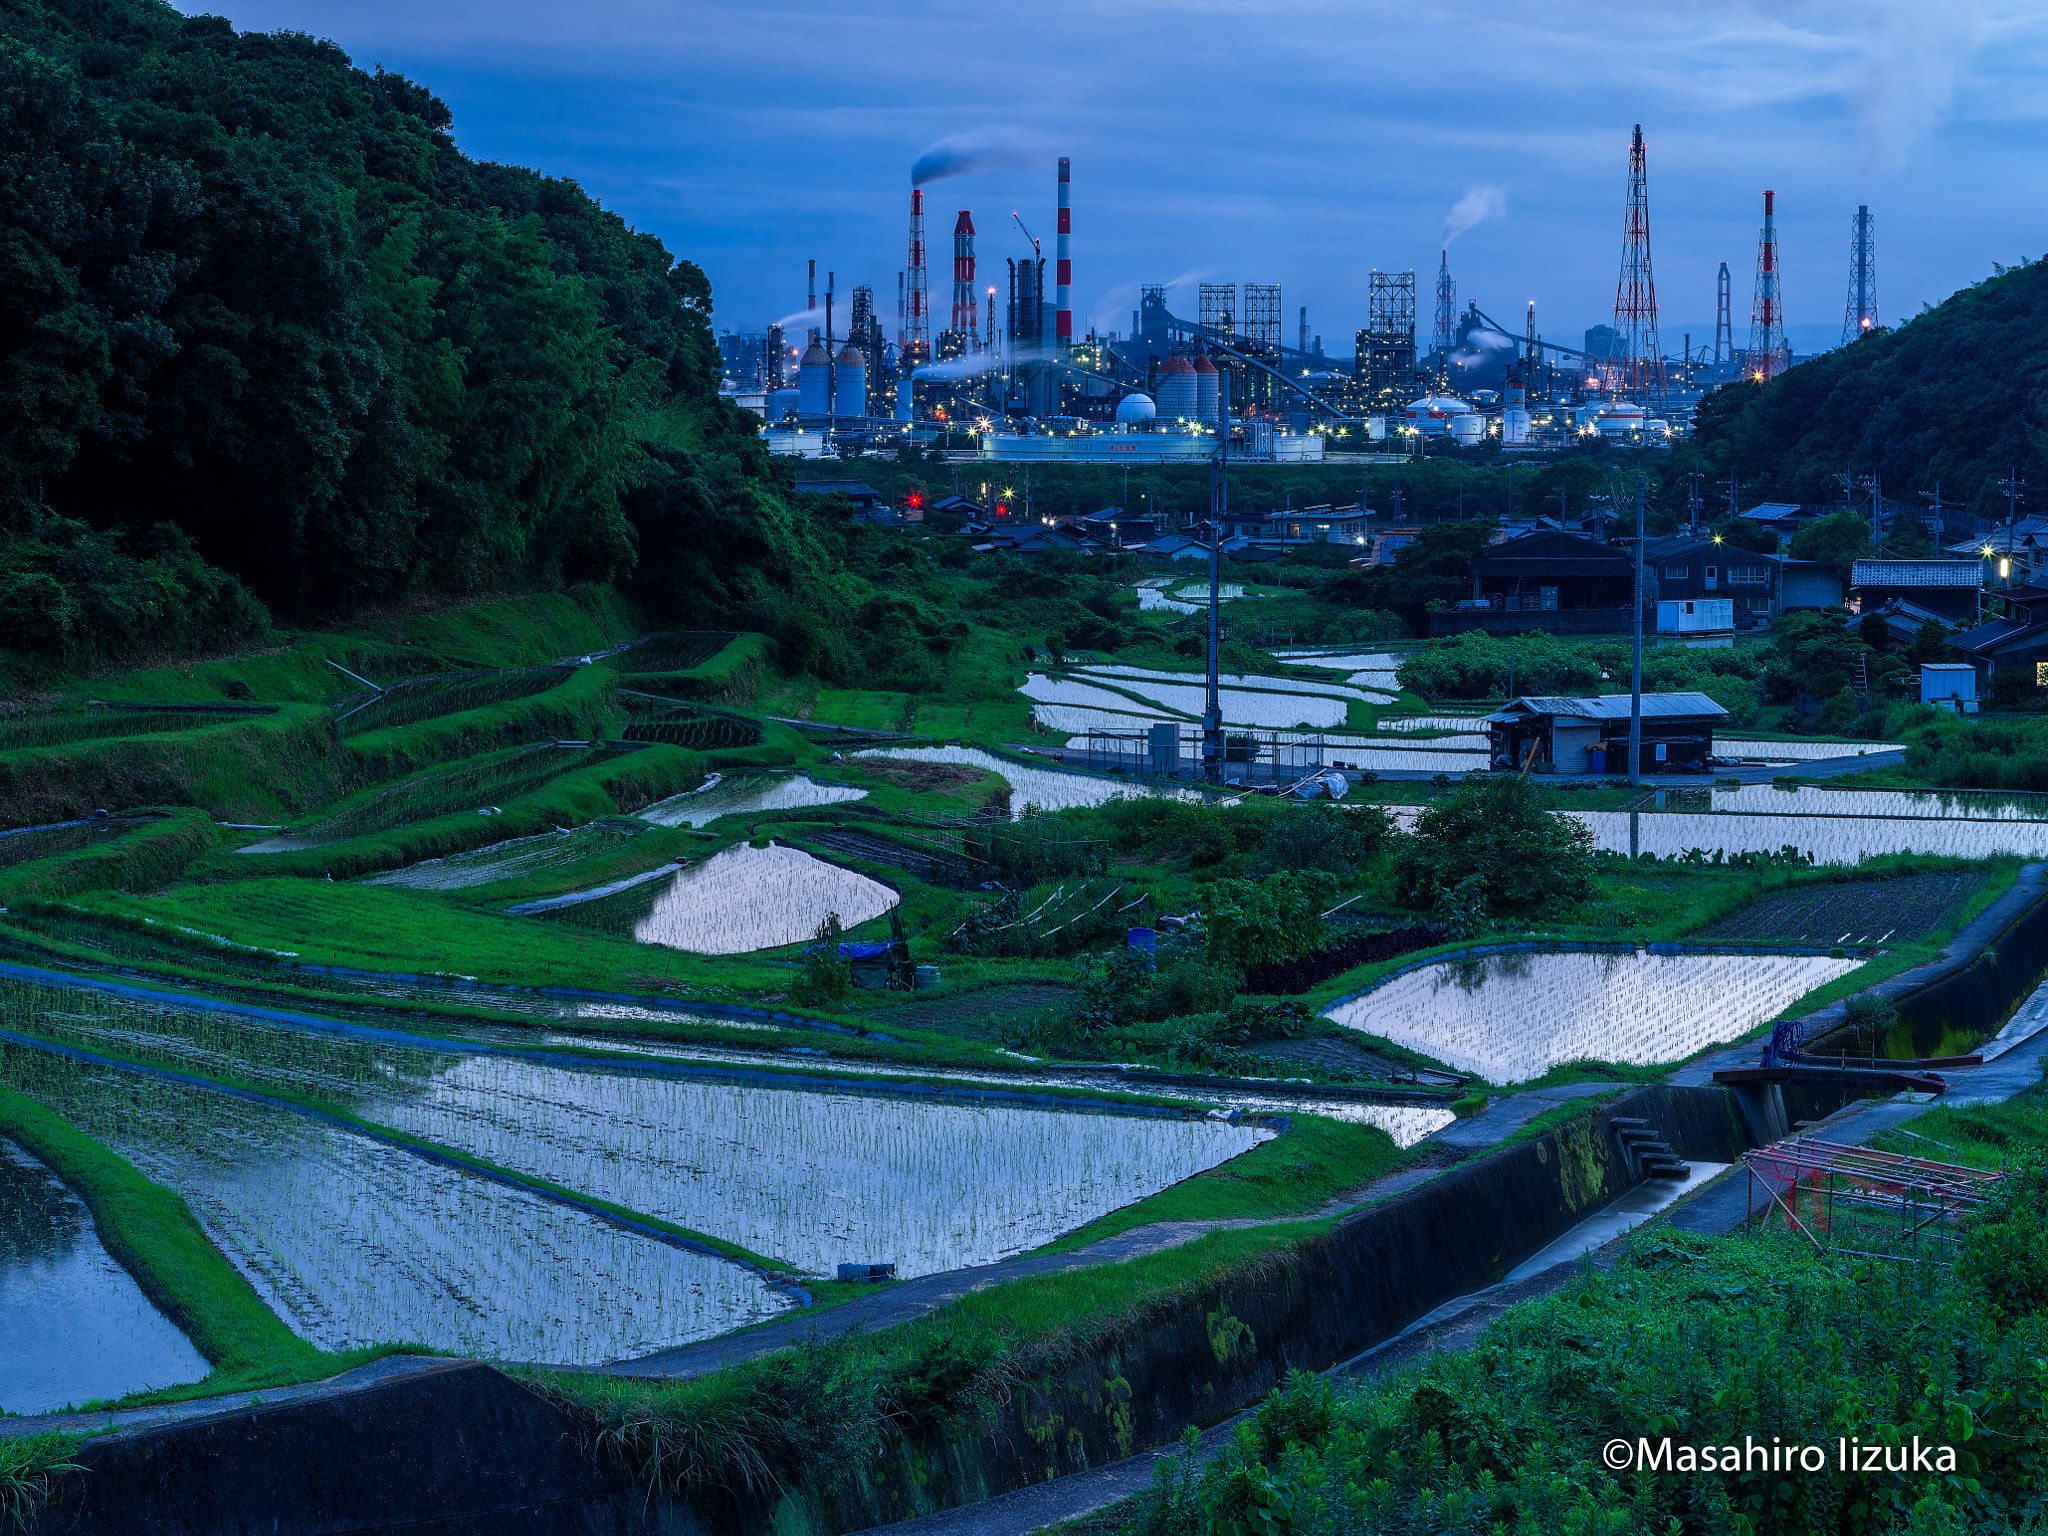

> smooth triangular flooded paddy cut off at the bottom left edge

[{"left": 0, "top": 1139, "right": 211, "bottom": 1413}]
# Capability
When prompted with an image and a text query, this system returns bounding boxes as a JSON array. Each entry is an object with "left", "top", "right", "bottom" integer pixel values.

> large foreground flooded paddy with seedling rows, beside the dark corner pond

[{"left": 0, "top": 1042, "right": 788, "bottom": 1364}]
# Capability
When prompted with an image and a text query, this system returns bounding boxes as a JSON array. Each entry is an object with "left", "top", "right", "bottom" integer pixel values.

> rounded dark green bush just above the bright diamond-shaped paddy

[{"left": 1395, "top": 774, "right": 1593, "bottom": 913}]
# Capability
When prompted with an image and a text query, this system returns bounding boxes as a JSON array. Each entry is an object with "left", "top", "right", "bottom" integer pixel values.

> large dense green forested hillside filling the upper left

[{"left": 0, "top": 0, "right": 860, "bottom": 668}]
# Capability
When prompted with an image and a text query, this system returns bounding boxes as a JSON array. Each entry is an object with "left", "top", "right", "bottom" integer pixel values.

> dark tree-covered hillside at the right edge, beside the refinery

[{"left": 1675, "top": 258, "right": 2048, "bottom": 516}]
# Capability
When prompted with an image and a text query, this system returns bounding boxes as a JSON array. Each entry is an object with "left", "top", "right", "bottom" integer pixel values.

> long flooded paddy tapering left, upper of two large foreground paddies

[{"left": 12, "top": 983, "right": 1272, "bottom": 1277}]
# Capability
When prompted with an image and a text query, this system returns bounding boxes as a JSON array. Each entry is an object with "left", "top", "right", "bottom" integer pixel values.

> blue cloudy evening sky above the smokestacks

[{"left": 184, "top": 0, "right": 2048, "bottom": 354}]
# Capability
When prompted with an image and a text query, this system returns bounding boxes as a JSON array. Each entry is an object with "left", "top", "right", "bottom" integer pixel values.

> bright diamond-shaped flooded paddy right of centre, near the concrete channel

[{"left": 1327, "top": 952, "right": 1860, "bottom": 1083}]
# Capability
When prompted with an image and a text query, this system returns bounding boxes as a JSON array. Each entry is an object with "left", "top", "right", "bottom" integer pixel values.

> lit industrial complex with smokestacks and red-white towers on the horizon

[{"left": 719, "top": 125, "right": 1878, "bottom": 463}]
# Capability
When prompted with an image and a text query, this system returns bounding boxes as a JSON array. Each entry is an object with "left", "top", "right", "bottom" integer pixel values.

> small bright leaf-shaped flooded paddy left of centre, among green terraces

[{"left": 551, "top": 844, "right": 901, "bottom": 954}]
